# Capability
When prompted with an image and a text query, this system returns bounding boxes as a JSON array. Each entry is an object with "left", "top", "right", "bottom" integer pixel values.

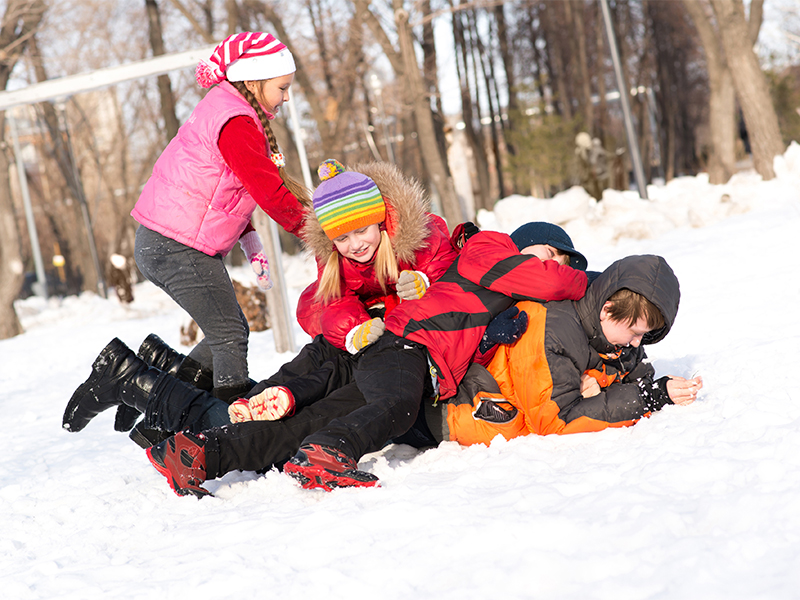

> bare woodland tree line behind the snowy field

[{"left": 0, "top": 0, "right": 800, "bottom": 338}]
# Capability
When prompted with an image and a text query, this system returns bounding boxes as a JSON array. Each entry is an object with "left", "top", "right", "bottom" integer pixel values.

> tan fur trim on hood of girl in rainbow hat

[{"left": 300, "top": 162, "right": 430, "bottom": 263}]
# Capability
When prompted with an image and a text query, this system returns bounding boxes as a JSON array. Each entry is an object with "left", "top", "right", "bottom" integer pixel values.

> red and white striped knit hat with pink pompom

[{"left": 195, "top": 31, "right": 295, "bottom": 88}]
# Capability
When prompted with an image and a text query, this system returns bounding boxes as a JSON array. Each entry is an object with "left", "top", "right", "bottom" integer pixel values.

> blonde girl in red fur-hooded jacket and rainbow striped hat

[{"left": 229, "top": 159, "right": 456, "bottom": 422}]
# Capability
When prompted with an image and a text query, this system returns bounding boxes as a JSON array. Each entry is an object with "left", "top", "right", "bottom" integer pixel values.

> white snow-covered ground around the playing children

[{"left": 0, "top": 144, "right": 800, "bottom": 600}]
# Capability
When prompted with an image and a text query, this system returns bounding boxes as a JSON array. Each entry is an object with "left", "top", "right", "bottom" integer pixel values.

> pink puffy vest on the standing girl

[{"left": 131, "top": 81, "right": 266, "bottom": 256}]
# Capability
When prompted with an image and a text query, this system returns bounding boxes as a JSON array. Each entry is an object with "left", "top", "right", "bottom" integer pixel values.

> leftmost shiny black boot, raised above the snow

[{"left": 62, "top": 338, "right": 160, "bottom": 432}]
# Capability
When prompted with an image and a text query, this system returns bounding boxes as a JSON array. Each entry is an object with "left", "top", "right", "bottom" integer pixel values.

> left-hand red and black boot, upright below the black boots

[{"left": 147, "top": 431, "right": 213, "bottom": 498}]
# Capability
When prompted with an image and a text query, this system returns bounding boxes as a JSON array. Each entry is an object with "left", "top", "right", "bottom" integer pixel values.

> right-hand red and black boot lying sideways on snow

[{"left": 283, "top": 444, "right": 379, "bottom": 492}]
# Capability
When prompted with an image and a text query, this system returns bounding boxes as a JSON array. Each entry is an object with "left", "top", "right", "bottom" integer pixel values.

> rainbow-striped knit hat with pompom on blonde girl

[{"left": 312, "top": 158, "right": 386, "bottom": 240}]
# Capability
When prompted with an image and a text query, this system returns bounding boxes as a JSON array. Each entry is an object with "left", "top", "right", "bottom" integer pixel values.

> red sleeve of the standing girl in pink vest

[{"left": 219, "top": 116, "right": 304, "bottom": 235}]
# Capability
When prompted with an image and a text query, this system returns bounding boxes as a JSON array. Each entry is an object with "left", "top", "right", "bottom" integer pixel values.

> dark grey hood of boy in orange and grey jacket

[{"left": 575, "top": 255, "right": 681, "bottom": 352}]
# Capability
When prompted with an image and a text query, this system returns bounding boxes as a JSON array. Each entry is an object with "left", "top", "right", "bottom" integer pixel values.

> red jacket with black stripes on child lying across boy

[{"left": 386, "top": 231, "right": 587, "bottom": 399}]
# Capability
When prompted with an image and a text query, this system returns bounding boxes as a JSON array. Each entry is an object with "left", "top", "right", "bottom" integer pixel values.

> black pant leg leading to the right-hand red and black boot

[{"left": 303, "top": 331, "right": 433, "bottom": 461}]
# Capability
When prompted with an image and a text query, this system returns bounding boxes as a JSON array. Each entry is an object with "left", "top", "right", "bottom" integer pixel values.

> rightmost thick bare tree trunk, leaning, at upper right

[{"left": 711, "top": 0, "right": 785, "bottom": 180}]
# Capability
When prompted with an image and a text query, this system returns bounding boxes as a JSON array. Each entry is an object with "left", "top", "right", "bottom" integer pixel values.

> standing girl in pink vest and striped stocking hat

[{"left": 130, "top": 32, "right": 310, "bottom": 408}]
